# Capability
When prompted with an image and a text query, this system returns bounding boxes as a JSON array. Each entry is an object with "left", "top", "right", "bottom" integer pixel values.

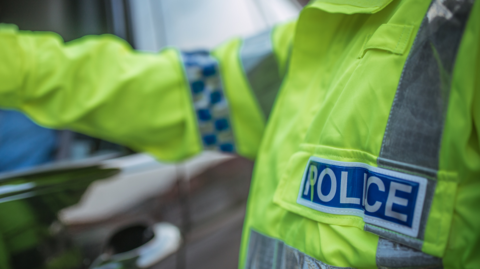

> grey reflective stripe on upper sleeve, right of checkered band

[{"left": 240, "top": 30, "right": 282, "bottom": 119}]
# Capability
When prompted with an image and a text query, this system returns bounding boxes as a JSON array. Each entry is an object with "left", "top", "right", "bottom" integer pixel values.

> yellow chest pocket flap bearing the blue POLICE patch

[{"left": 274, "top": 146, "right": 458, "bottom": 257}]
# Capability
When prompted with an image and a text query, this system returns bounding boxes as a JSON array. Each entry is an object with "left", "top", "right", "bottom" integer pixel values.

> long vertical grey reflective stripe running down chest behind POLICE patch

[{"left": 372, "top": 0, "right": 474, "bottom": 250}]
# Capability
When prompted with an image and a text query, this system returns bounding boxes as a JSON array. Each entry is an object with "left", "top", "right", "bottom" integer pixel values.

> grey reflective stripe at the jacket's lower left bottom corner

[{"left": 245, "top": 230, "right": 349, "bottom": 269}]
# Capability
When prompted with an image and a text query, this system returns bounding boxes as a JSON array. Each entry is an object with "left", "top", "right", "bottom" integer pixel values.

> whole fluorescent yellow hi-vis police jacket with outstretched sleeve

[{"left": 0, "top": 0, "right": 480, "bottom": 269}]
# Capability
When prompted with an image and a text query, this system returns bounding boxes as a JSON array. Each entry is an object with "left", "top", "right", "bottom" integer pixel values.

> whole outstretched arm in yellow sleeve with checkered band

[{"left": 0, "top": 24, "right": 293, "bottom": 161}]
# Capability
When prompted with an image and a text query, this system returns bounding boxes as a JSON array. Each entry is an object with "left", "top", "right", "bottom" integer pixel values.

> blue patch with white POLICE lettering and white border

[{"left": 297, "top": 157, "right": 427, "bottom": 237}]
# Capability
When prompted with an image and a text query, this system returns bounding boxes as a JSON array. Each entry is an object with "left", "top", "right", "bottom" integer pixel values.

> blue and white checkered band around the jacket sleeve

[{"left": 182, "top": 51, "right": 235, "bottom": 152}]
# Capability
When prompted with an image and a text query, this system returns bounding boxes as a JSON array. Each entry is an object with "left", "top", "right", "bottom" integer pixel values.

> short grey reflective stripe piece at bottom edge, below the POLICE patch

[{"left": 376, "top": 238, "right": 443, "bottom": 269}]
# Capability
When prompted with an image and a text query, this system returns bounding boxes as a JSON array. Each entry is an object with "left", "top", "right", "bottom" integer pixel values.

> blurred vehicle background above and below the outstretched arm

[{"left": 0, "top": 0, "right": 300, "bottom": 269}]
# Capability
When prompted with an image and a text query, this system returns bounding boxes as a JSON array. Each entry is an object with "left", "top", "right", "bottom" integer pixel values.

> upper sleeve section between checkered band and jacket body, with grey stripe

[{"left": 204, "top": 22, "right": 295, "bottom": 158}]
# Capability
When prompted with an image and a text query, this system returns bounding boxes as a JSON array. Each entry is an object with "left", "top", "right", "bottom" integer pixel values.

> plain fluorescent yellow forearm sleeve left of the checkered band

[{"left": 0, "top": 25, "right": 202, "bottom": 161}]
